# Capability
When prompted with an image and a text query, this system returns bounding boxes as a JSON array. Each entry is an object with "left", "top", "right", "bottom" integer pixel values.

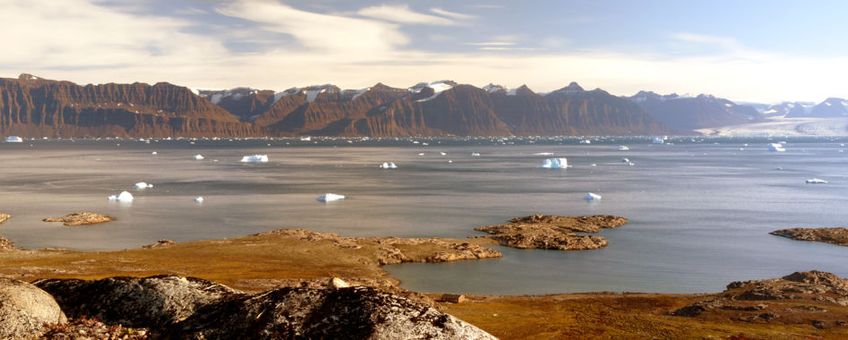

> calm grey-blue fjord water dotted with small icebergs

[{"left": 0, "top": 139, "right": 848, "bottom": 294}]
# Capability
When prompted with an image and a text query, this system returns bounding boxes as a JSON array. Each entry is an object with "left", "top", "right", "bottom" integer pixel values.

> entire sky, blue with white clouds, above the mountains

[{"left": 0, "top": 0, "right": 848, "bottom": 103}]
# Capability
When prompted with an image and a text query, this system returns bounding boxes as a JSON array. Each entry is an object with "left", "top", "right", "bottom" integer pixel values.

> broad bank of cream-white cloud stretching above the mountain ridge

[{"left": 0, "top": 0, "right": 848, "bottom": 101}]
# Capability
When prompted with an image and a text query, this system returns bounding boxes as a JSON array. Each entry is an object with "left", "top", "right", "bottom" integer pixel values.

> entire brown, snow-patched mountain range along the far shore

[{"left": 0, "top": 74, "right": 848, "bottom": 137}]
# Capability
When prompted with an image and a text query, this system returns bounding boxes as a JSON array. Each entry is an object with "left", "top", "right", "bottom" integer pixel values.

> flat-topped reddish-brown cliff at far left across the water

[{"left": 0, "top": 75, "right": 256, "bottom": 137}]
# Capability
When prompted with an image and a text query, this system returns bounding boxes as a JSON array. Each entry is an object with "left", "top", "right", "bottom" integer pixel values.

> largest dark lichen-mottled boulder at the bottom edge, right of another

[{"left": 167, "top": 287, "right": 494, "bottom": 339}]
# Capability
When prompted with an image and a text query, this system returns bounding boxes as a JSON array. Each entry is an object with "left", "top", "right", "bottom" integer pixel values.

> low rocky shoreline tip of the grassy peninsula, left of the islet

[{"left": 256, "top": 229, "right": 503, "bottom": 265}]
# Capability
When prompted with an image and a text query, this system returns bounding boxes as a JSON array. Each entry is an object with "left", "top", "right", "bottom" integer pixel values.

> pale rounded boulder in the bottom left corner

[{"left": 0, "top": 278, "right": 67, "bottom": 339}]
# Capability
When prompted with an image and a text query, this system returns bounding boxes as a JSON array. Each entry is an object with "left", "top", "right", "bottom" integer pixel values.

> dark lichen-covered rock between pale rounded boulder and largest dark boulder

[{"left": 34, "top": 276, "right": 241, "bottom": 328}]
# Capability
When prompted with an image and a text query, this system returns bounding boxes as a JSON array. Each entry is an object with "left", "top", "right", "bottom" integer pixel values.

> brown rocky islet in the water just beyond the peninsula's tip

[{"left": 474, "top": 215, "right": 627, "bottom": 250}]
